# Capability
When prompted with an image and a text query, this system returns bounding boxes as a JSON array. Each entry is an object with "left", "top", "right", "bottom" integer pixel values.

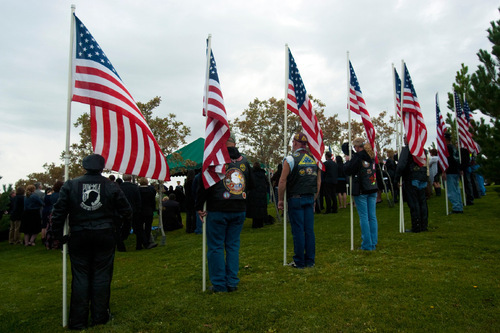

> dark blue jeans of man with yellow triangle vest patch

[{"left": 288, "top": 195, "right": 316, "bottom": 268}]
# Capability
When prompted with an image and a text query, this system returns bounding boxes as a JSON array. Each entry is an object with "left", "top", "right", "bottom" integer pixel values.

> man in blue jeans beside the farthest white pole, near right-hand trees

[{"left": 443, "top": 133, "right": 464, "bottom": 214}]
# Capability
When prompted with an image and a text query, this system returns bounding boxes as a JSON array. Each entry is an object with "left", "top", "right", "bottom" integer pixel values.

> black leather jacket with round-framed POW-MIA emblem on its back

[{"left": 52, "top": 172, "right": 132, "bottom": 239}]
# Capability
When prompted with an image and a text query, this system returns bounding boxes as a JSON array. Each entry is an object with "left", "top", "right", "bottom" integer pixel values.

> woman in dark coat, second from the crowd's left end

[{"left": 20, "top": 185, "right": 43, "bottom": 246}]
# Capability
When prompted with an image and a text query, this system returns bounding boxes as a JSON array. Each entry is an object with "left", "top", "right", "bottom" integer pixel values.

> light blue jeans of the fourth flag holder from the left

[{"left": 354, "top": 193, "right": 378, "bottom": 251}]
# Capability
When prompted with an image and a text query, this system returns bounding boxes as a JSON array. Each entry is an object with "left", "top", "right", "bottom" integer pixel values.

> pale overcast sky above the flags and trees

[{"left": 0, "top": 0, "right": 499, "bottom": 184}]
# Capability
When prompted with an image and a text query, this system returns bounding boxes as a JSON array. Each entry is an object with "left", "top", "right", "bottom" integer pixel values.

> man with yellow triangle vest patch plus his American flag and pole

[{"left": 278, "top": 45, "right": 325, "bottom": 268}]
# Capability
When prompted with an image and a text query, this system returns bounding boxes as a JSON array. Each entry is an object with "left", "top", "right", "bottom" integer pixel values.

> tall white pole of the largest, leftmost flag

[{"left": 62, "top": 5, "right": 76, "bottom": 327}]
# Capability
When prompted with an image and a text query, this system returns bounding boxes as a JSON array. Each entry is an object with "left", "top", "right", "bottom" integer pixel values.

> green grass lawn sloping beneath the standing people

[{"left": 0, "top": 186, "right": 500, "bottom": 332}]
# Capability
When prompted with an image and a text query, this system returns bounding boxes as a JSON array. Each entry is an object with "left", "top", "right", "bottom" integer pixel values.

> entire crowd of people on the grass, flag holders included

[{"left": 1, "top": 133, "right": 485, "bottom": 329}]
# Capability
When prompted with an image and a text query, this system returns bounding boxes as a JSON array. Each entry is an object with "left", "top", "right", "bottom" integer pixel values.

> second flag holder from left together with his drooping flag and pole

[{"left": 195, "top": 35, "right": 253, "bottom": 292}]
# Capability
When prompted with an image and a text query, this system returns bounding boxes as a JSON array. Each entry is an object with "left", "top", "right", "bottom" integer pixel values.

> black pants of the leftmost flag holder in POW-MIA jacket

[{"left": 68, "top": 229, "right": 115, "bottom": 329}]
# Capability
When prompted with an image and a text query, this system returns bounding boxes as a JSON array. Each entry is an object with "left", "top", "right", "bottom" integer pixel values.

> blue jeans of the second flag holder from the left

[{"left": 207, "top": 212, "right": 246, "bottom": 291}]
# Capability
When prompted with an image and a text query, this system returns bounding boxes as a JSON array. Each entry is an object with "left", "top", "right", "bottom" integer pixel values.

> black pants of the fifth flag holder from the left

[{"left": 404, "top": 181, "right": 429, "bottom": 232}]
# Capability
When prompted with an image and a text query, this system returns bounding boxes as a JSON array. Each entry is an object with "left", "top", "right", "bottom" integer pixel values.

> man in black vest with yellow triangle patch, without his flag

[{"left": 278, "top": 133, "right": 321, "bottom": 268}]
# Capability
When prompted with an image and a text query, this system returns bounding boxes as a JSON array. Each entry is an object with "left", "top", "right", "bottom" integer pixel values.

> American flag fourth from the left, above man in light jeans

[{"left": 347, "top": 60, "right": 378, "bottom": 164}]
